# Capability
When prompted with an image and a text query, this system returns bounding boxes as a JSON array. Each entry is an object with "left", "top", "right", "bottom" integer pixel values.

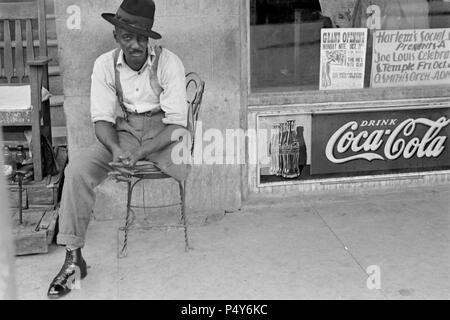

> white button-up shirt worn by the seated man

[{"left": 91, "top": 47, "right": 188, "bottom": 127}]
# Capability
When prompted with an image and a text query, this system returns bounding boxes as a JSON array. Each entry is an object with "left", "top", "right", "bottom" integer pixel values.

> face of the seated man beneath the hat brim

[{"left": 114, "top": 28, "right": 148, "bottom": 65}]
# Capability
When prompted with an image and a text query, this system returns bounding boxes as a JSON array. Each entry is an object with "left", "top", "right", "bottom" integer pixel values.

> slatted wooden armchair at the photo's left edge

[{"left": 0, "top": 0, "right": 52, "bottom": 181}]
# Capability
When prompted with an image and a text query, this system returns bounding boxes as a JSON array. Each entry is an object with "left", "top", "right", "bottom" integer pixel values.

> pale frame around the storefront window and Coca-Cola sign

[{"left": 240, "top": 0, "right": 450, "bottom": 192}]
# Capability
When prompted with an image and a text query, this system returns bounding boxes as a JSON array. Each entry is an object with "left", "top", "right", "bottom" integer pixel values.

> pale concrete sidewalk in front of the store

[{"left": 16, "top": 185, "right": 450, "bottom": 299}]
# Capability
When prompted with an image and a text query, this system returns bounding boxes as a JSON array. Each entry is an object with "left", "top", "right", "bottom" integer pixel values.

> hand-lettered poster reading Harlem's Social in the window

[{"left": 370, "top": 28, "right": 450, "bottom": 88}]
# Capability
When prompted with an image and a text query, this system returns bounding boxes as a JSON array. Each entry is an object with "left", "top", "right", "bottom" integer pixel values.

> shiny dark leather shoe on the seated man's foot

[{"left": 47, "top": 248, "right": 87, "bottom": 299}]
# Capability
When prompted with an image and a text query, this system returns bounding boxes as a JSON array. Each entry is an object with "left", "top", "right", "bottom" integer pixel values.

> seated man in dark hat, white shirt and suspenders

[{"left": 48, "top": 0, "right": 189, "bottom": 298}]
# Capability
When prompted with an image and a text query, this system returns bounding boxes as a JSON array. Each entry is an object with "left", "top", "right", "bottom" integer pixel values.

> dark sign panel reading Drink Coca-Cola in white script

[{"left": 311, "top": 108, "right": 450, "bottom": 174}]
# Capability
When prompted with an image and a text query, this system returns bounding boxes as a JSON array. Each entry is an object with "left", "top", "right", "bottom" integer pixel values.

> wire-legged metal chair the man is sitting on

[{"left": 109, "top": 72, "right": 205, "bottom": 258}]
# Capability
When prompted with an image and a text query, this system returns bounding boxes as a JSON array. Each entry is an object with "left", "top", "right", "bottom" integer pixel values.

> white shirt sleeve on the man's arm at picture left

[{"left": 91, "top": 59, "right": 117, "bottom": 123}]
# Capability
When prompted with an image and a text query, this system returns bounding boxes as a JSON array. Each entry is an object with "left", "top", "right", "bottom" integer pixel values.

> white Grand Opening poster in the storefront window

[{"left": 319, "top": 28, "right": 367, "bottom": 90}]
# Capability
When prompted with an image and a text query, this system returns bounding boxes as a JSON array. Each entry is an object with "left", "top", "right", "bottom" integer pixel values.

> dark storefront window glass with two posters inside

[{"left": 250, "top": 0, "right": 450, "bottom": 92}]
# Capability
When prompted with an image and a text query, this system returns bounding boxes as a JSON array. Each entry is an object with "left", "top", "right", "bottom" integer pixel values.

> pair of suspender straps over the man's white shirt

[{"left": 113, "top": 46, "right": 163, "bottom": 121}]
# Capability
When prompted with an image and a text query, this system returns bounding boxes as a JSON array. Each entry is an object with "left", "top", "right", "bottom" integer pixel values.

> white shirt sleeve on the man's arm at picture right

[{"left": 158, "top": 52, "right": 188, "bottom": 127}]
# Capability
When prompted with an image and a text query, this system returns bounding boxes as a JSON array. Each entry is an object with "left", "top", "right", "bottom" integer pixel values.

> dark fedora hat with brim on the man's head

[{"left": 102, "top": 0, "right": 161, "bottom": 39}]
